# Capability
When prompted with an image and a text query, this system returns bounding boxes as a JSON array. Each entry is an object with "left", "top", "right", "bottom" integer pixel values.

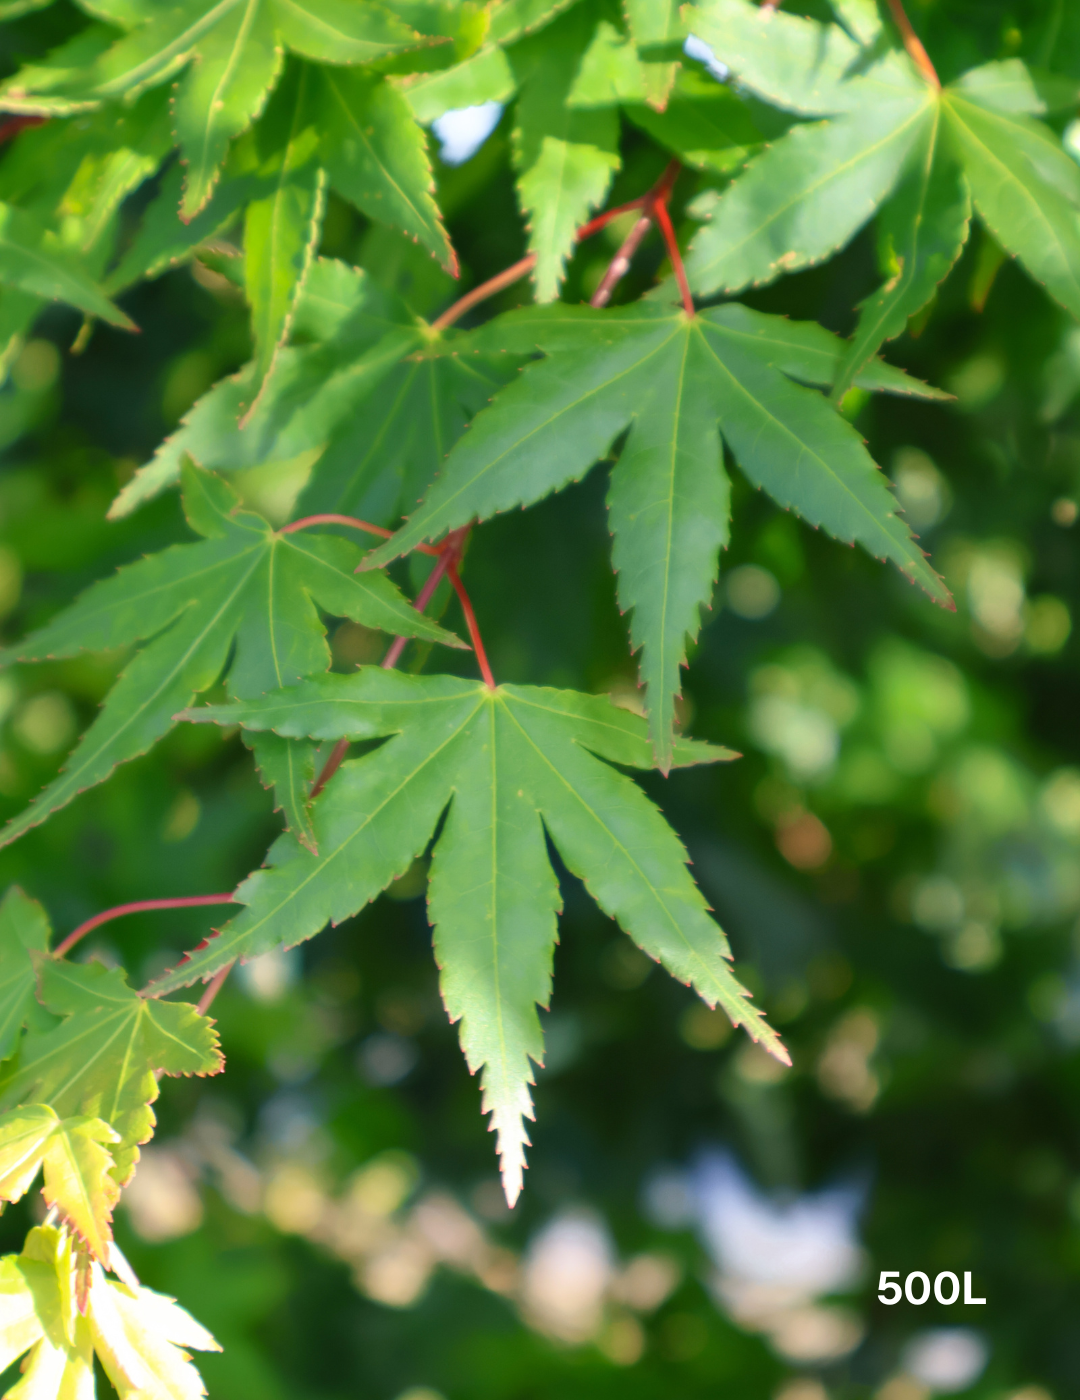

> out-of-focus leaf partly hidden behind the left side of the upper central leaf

[{"left": 109, "top": 258, "right": 521, "bottom": 525}]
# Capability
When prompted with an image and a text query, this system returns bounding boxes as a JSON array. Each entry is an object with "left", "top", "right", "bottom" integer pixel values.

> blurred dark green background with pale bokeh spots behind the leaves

[{"left": 0, "top": 0, "right": 1080, "bottom": 1400}]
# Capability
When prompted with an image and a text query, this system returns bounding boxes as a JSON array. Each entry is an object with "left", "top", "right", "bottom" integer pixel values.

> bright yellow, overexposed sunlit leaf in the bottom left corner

[{"left": 0, "top": 1225, "right": 221, "bottom": 1400}]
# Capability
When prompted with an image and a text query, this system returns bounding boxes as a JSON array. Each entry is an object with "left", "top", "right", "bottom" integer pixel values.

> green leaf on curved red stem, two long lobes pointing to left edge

[{"left": 0, "top": 463, "right": 459, "bottom": 844}]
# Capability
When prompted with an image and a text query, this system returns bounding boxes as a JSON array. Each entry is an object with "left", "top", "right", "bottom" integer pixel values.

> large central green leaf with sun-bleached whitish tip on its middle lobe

[{"left": 151, "top": 666, "right": 786, "bottom": 1203}]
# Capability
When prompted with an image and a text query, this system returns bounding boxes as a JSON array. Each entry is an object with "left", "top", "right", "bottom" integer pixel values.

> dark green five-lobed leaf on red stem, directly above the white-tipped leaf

[{"left": 370, "top": 302, "right": 948, "bottom": 769}]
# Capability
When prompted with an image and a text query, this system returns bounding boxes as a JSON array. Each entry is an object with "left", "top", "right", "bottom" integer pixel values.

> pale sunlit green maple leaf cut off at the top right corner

[{"left": 686, "top": 0, "right": 1080, "bottom": 364}]
